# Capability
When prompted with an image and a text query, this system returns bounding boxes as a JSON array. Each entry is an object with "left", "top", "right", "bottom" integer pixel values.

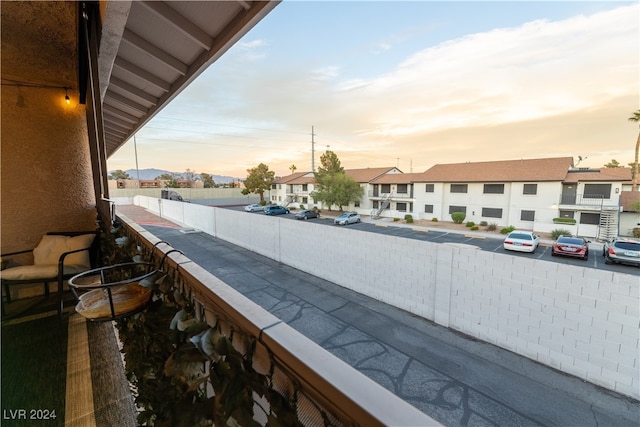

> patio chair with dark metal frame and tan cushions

[{"left": 0, "top": 231, "right": 99, "bottom": 317}]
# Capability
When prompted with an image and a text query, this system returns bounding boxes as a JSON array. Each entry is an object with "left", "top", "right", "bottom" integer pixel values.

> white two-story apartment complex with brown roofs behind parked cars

[{"left": 271, "top": 157, "right": 638, "bottom": 239}]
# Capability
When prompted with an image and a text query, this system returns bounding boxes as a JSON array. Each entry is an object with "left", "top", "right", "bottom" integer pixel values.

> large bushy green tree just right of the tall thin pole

[{"left": 310, "top": 150, "right": 363, "bottom": 211}]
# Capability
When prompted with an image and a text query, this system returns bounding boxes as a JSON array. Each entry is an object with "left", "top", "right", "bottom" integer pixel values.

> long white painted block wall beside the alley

[{"left": 133, "top": 196, "right": 640, "bottom": 399}]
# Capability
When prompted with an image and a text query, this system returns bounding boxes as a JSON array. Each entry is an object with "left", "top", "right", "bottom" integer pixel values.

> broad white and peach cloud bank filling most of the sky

[{"left": 110, "top": 4, "right": 640, "bottom": 177}]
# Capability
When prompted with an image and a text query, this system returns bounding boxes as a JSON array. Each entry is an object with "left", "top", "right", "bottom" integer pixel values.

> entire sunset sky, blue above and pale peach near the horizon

[{"left": 107, "top": 0, "right": 640, "bottom": 179}]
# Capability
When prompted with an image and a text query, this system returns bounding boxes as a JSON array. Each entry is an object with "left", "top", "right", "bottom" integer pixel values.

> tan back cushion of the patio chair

[{"left": 33, "top": 234, "right": 95, "bottom": 268}]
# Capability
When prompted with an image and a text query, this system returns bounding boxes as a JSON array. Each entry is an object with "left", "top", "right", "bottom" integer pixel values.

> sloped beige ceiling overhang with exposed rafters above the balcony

[{"left": 98, "top": 0, "right": 280, "bottom": 157}]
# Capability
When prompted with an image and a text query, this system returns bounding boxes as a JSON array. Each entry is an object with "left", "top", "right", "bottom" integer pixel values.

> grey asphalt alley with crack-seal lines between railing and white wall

[{"left": 118, "top": 206, "right": 640, "bottom": 427}]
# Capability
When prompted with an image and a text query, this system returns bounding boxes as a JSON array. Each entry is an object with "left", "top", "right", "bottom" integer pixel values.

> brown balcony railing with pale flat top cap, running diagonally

[{"left": 115, "top": 218, "right": 440, "bottom": 426}]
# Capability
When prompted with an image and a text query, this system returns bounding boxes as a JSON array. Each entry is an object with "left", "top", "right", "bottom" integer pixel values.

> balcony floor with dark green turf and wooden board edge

[{"left": 2, "top": 293, "right": 137, "bottom": 427}]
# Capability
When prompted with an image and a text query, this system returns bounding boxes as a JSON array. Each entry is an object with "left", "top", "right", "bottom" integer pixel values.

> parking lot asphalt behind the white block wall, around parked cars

[{"left": 234, "top": 206, "right": 640, "bottom": 276}]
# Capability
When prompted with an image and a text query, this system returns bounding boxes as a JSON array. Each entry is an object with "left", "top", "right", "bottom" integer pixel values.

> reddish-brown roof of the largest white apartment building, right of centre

[{"left": 414, "top": 157, "right": 573, "bottom": 182}]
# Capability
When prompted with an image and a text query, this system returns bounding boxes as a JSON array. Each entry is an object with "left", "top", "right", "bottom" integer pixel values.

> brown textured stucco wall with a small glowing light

[{"left": 0, "top": 2, "right": 96, "bottom": 252}]
